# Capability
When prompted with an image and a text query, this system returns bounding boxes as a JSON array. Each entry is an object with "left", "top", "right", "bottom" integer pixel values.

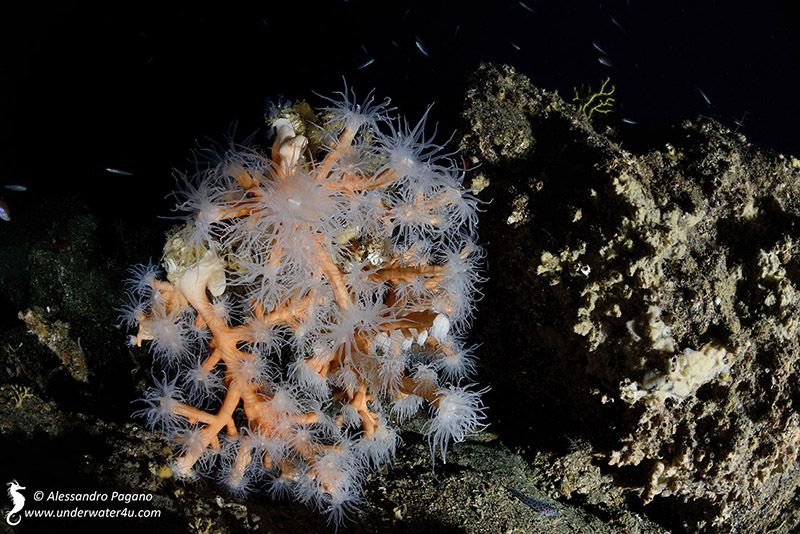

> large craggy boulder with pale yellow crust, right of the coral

[{"left": 462, "top": 61, "right": 800, "bottom": 532}]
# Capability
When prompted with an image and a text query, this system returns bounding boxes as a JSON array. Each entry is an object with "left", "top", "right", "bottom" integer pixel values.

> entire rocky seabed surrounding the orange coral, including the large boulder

[{"left": 0, "top": 65, "right": 800, "bottom": 534}]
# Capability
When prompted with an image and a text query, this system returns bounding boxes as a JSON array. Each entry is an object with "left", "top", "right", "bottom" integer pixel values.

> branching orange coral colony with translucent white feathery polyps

[{"left": 124, "top": 90, "right": 483, "bottom": 524}]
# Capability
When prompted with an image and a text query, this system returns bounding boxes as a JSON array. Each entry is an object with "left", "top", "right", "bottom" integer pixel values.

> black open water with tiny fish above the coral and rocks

[{"left": 0, "top": 0, "right": 800, "bottom": 220}]
